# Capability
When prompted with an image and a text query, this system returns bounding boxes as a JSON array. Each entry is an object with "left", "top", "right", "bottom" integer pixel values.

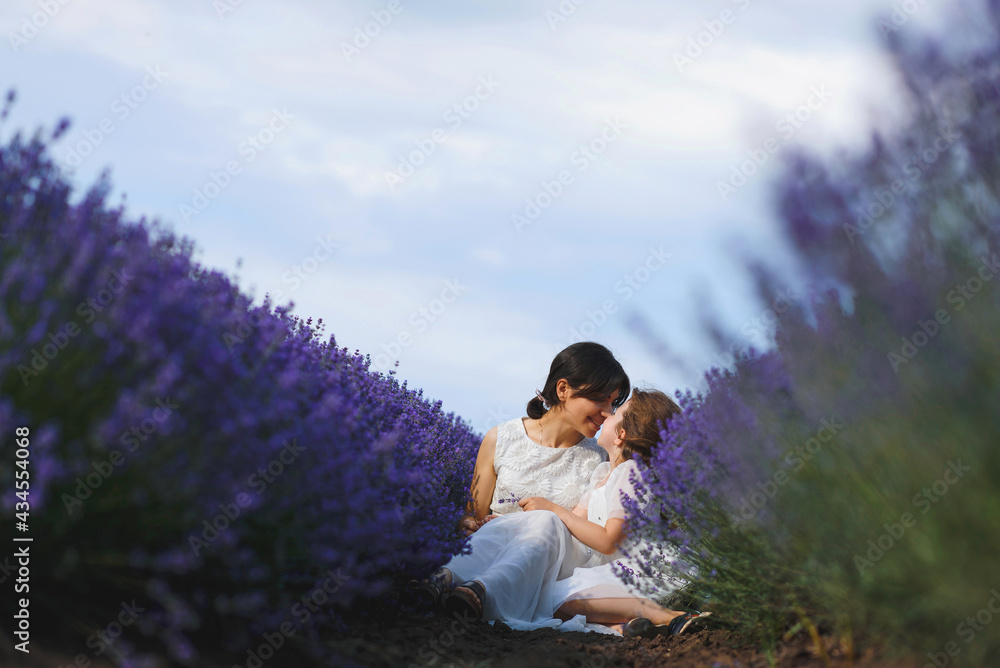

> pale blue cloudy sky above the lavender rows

[{"left": 0, "top": 0, "right": 959, "bottom": 431}]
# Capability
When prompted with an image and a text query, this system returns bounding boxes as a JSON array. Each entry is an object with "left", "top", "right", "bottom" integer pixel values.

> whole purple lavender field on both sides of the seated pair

[{"left": 0, "top": 2, "right": 1000, "bottom": 668}]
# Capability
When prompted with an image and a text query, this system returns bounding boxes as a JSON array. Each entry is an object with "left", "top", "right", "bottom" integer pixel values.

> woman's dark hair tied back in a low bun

[{"left": 528, "top": 341, "right": 631, "bottom": 420}]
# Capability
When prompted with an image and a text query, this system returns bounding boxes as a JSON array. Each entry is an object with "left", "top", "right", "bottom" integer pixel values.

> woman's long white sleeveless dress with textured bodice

[{"left": 444, "top": 418, "right": 607, "bottom": 622}]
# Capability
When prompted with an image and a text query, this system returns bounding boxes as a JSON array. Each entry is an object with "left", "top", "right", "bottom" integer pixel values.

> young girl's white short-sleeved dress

[{"left": 547, "top": 460, "right": 683, "bottom": 630}]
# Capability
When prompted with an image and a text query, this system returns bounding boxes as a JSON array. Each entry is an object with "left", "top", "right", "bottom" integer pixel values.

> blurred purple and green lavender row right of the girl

[{"left": 628, "top": 2, "right": 1000, "bottom": 666}]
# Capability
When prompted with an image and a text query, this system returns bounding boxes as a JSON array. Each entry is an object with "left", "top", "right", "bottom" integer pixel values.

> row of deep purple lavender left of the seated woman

[{"left": 0, "top": 95, "right": 479, "bottom": 663}]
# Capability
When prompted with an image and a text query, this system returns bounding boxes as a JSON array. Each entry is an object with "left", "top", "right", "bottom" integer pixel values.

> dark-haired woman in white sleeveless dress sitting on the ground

[{"left": 421, "top": 342, "right": 629, "bottom": 619}]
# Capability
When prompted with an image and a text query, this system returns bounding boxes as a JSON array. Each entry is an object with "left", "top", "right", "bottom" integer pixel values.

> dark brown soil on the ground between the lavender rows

[{"left": 0, "top": 616, "right": 920, "bottom": 668}]
